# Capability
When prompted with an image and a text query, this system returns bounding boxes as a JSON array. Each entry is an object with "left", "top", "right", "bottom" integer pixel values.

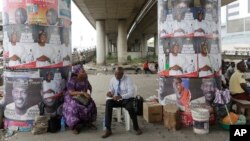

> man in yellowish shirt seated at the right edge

[{"left": 229, "top": 61, "right": 250, "bottom": 101}]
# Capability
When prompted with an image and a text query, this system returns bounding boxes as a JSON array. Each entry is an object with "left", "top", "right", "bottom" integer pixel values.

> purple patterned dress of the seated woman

[{"left": 63, "top": 78, "right": 97, "bottom": 129}]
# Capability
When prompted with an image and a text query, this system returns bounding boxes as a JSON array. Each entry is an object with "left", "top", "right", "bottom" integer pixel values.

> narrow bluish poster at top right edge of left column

[{"left": 58, "top": 0, "right": 71, "bottom": 20}]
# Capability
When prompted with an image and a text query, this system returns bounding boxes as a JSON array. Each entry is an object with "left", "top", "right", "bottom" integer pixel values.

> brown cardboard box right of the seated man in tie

[{"left": 143, "top": 102, "right": 162, "bottom": 123}]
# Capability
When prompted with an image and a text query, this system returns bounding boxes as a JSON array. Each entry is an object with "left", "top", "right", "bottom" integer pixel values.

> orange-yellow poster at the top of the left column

[{"left": 26, "top": 0, "right": 59, "bottom": 26}]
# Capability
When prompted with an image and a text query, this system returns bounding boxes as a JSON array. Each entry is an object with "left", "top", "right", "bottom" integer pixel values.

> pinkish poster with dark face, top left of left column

[{"left": 3, "top": 0, "right": 28, "bottom": 25}]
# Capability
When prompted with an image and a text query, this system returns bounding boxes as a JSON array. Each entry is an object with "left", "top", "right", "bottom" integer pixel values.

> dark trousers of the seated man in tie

[{"left": 105, "top": 98, "right": 139, "bottom": 131}]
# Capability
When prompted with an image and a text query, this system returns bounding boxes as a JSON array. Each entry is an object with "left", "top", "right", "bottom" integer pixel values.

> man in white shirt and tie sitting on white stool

[{"left": 102, "top": 67, "right": 142, "bottom": 138}]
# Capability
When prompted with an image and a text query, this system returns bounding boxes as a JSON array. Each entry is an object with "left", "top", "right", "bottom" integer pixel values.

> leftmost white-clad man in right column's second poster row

[{"left": 169, "top": 43, "right": 186, "bottom": 76}]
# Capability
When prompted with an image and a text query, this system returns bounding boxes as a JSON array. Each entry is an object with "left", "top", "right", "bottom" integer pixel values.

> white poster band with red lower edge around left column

[{"left": 4, "top": 25, "right": 72, "bottom": 69}]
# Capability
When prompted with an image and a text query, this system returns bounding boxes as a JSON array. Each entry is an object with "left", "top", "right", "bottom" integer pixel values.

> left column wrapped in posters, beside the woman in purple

[{"left": 1, "top": 0, "right": 72, "bottom": 131}]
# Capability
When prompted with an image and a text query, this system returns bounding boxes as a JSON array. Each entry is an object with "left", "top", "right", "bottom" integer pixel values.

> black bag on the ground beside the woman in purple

[{"left": 48, "top": 115, "right": 61, "bottom": 133}]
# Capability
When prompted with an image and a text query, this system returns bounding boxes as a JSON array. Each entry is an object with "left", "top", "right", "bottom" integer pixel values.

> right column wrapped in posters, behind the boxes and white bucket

[{"left": 158, "top": 0, "right": 221, "bottom": 126}]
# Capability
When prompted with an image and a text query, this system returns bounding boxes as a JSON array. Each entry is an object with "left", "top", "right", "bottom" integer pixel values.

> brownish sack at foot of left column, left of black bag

[{"left": 31, "top": 116, "right": 49, "bottom": 135}]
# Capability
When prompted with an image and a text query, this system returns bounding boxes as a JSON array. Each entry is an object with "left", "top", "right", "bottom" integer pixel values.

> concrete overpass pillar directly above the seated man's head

[{"left": 117, "top": 20, "right": 127, "bottom": 64}]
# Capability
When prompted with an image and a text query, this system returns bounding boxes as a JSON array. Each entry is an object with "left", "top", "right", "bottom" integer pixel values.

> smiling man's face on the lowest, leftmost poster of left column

[{"left": 12, "top": 87, "right": 28, "bottom": 109}]
